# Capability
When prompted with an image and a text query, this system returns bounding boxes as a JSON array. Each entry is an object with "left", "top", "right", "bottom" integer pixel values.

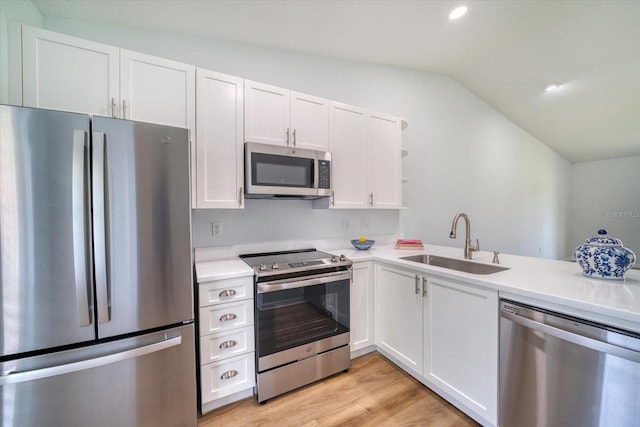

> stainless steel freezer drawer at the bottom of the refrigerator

[{"left": 0, "top": 324, "right": 197, "bottom": 427}]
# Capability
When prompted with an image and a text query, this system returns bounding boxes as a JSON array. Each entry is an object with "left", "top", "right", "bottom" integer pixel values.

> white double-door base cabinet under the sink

[{"left": 375, "top": 264, "right": 498, "bottom": 425}]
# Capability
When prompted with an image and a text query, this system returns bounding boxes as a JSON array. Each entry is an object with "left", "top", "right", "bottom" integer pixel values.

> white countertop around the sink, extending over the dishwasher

[{"left": 330, "top": 245, "right": 640, "bottom": 333}]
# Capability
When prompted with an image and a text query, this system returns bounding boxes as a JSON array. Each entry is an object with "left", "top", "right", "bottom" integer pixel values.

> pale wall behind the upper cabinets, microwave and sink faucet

[{"left": 10, "top": 10, "right": 570, "bottom": 258}]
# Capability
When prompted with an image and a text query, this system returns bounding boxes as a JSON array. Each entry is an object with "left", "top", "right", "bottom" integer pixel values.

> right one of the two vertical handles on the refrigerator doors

[{"left": 91, "top": 132, "right": 111, "bottom": 323}]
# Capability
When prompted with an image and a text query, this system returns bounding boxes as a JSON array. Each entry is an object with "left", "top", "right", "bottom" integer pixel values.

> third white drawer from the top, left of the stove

[{"left": 200, "top": 326, "right": 254, "bottom": 364}]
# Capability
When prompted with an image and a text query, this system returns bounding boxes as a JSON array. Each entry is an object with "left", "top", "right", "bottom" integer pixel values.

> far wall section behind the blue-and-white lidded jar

[{"left": 570, "top": 156, "right": 640, "bottom": 256}]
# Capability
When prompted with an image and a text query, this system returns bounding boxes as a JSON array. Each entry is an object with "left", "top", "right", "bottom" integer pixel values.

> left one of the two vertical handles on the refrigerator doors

[{"left": 71, "top": 129, "right": 91, "bottom": 326}]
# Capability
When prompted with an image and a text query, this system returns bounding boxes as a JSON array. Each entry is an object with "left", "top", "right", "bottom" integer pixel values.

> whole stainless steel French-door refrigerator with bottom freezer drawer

[{"left": 0, "top": 105, "right": 197, "bottom": 427}]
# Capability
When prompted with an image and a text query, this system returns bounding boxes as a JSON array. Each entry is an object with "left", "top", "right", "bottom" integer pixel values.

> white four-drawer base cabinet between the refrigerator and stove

[{"left": 198, "top": 276, "right": 256, "bottom": 414}]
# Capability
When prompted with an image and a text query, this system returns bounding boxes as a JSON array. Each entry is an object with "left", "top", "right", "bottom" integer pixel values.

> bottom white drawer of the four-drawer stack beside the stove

[{"left": 200, "top": 352, "right": 256, "bottom": 403}]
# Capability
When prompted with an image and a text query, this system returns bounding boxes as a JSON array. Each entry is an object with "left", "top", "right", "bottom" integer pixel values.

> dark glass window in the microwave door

[{"left": 251, "top": 153, "right": 314, "bottom": 188}]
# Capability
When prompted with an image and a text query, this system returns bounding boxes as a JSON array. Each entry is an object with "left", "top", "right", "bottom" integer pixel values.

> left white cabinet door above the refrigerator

[{"left": 22, "top": 25, "right": 119, "bottom": 117}]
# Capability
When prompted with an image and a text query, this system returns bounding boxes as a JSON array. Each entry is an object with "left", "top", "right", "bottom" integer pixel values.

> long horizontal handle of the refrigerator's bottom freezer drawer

[{"left": 0, "top": 335, "right": 182, "bottom": 386}]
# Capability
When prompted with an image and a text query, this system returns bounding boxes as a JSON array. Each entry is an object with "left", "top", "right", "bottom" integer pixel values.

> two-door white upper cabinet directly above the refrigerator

[{"left": 22, "top": 25, "right": 195, "bottom": 132}]
